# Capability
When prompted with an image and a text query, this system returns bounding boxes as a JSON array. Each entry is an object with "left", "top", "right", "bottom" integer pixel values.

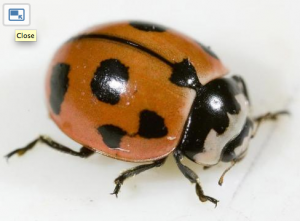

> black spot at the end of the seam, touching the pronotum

[{"left": 170, "top": 59, "right": 201, "bottom": 90}]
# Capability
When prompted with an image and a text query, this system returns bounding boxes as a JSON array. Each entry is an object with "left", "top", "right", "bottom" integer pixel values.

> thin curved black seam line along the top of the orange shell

[{"left": 69, "top": 34, "right": 173, "bottom": 67}]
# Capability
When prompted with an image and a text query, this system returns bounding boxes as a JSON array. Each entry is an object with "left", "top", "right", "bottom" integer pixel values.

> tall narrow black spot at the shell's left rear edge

[{"left": 50, "top": 63, "right": 70, "bottom": 115}]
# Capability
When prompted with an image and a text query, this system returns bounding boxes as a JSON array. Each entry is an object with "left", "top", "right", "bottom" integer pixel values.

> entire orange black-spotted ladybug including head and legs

[{"left": 6, "top": 21, "right": 287, "bottom": 205}]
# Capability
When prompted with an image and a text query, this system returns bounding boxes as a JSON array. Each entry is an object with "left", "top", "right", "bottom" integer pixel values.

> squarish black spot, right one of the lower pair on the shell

[{"left": 138, "top": 110, "right": 168, "bottom": 138}]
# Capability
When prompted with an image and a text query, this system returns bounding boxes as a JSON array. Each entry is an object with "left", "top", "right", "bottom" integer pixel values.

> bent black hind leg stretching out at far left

[{"left": 5, "top": 136, "right": 94, "bottom": 159}]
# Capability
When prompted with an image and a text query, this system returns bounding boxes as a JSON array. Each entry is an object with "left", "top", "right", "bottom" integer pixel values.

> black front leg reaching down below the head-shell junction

[{"left": 174, "top": 149, "right": 219, "bottom": 206}]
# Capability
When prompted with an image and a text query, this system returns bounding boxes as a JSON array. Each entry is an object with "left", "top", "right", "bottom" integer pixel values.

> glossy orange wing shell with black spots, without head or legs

[{"left": 46, "top": 22, "right": 227, "bottom": 162}]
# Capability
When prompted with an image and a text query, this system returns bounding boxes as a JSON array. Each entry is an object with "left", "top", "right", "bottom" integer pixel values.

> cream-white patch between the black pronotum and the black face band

[{"left": 193, "top": 94, "right": 249, "bottom": 165}]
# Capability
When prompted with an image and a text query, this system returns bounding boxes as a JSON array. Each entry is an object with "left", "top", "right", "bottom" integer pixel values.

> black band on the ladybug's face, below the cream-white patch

[{"left": 221, "top": 118, "right": 253, "bottom": 162}]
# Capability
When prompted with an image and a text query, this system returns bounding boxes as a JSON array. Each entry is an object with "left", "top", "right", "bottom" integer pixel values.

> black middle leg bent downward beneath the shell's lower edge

[{"left": 111, "top": 158, "right": 167, "bottom": 197}]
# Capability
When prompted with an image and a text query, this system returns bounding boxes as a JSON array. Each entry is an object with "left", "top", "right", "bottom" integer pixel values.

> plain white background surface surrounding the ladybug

[{"left": 0, "top": 0, "right": 300, "bottom": 221}]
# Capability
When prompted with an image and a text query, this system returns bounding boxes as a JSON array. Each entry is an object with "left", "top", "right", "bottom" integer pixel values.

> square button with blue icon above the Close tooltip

[{"left": 3, "top": 4, "right": 30, "bottom": 25}]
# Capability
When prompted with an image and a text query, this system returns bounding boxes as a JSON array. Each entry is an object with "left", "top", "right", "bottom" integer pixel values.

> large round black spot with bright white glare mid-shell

[{"left": 91, "top": 59, "right": 129, "bottom": 105}]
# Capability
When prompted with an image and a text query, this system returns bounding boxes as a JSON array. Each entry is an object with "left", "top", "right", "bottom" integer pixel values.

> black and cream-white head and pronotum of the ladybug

[{"left": 180, "top": 76, "right": 252, "bottom": 165}]
